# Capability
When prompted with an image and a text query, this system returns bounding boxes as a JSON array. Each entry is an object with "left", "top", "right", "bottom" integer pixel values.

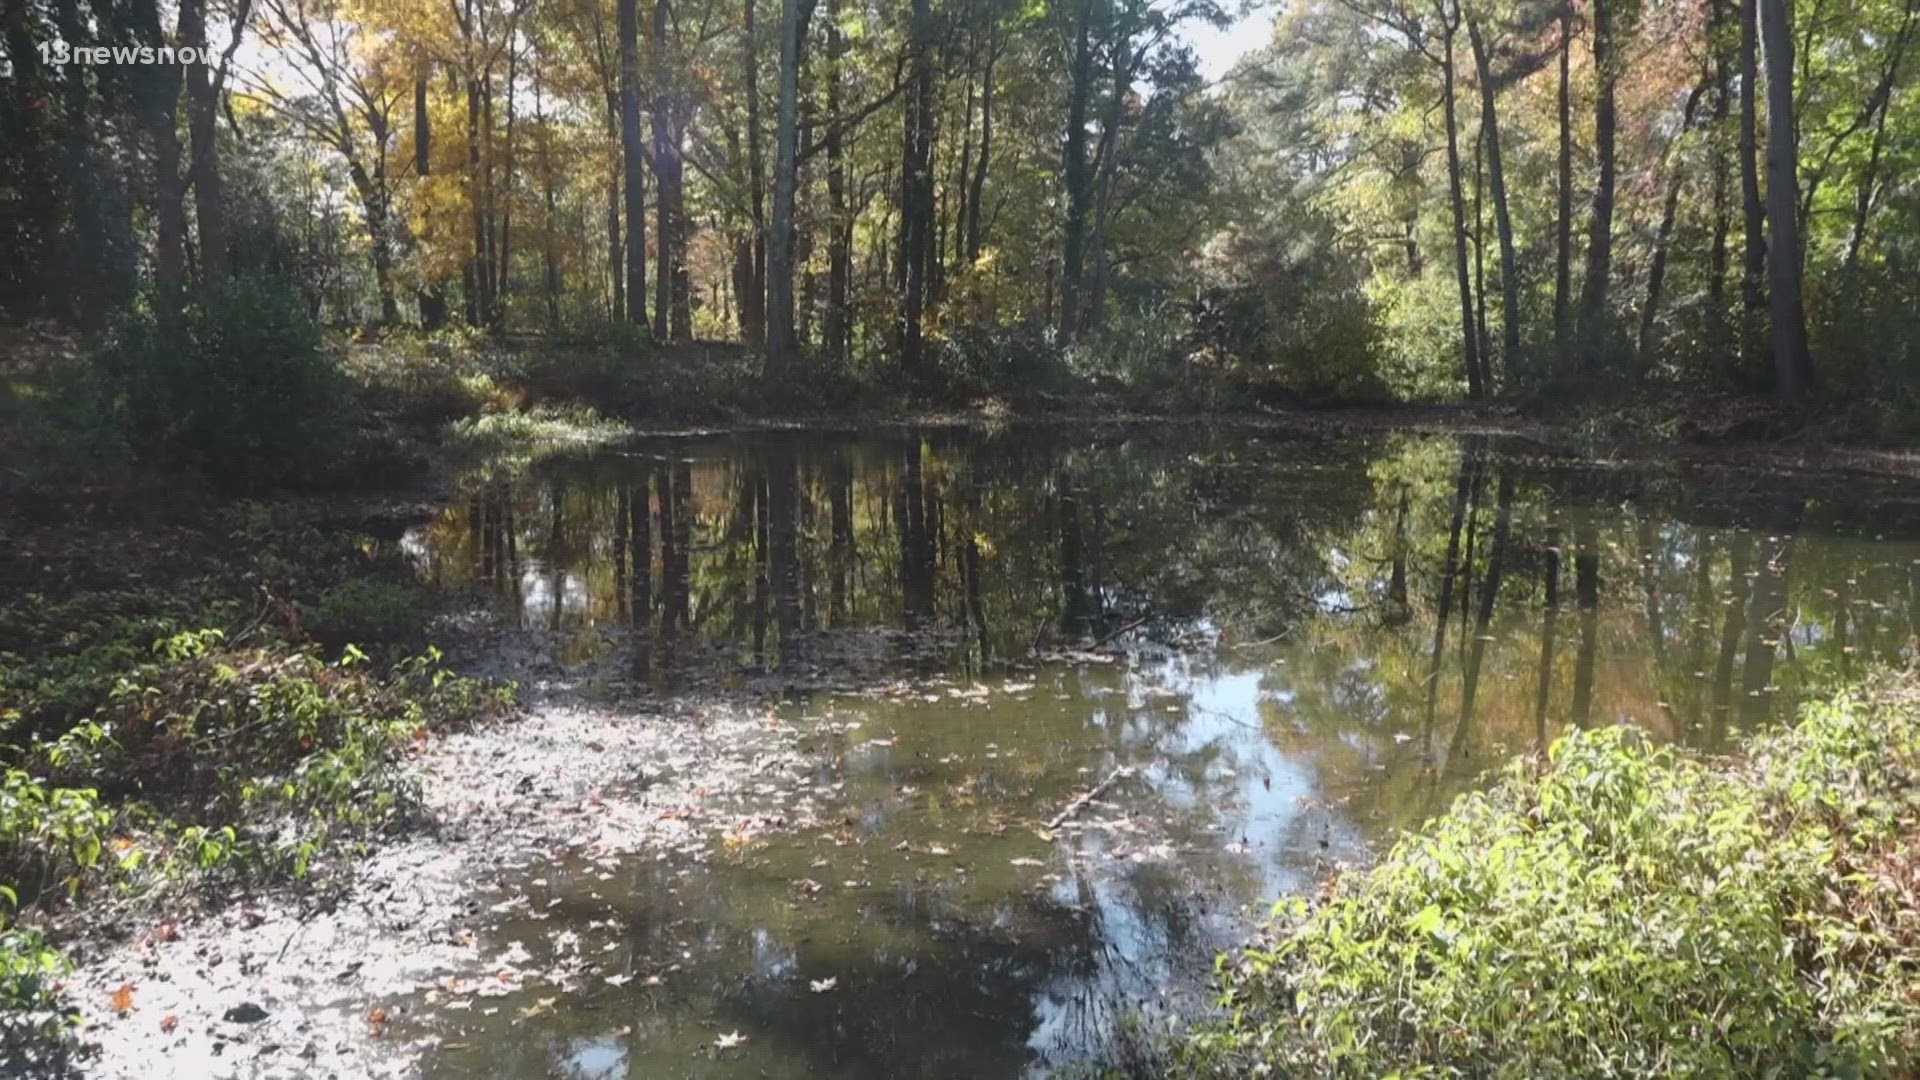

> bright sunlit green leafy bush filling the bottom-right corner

[{"left": 1171, "top": 678, "right": 1920, "bottom": 1076}]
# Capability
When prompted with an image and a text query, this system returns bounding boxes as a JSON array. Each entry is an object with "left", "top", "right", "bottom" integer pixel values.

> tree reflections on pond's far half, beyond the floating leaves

[{"left": 426, "top": 428, "right": 1916, "bottom": 749}]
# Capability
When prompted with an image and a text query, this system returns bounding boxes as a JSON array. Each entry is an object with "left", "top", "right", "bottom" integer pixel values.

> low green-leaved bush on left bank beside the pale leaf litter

[{"left": 0, "top": 628, "right": 511, "bottom": 899}]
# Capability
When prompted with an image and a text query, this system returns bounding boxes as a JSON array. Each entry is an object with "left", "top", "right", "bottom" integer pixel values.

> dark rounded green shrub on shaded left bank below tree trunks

[{"left": 94, "top": 279, "right": 348, "bottom": 488}]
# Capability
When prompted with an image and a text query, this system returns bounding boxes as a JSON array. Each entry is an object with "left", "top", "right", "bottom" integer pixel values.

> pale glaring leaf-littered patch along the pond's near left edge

[{"left": 67, "top": 630, "right": 820, "bottom": 1078}]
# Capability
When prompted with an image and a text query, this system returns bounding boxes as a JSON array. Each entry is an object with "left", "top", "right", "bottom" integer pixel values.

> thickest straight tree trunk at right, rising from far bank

[{"left": 1759, "top": 0, "right": 1814, "bottom": 400}]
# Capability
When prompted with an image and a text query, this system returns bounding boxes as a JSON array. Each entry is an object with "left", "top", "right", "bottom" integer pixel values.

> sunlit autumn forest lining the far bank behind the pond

[{"left": 0, "top": 0, "right": 1920, "bottom": 403}]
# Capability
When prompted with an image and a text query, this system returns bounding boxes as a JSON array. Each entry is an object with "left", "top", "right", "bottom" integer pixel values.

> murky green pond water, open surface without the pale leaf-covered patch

[{"left": 393, "top": 424, "right": 1920, "bottom": 1078}]
